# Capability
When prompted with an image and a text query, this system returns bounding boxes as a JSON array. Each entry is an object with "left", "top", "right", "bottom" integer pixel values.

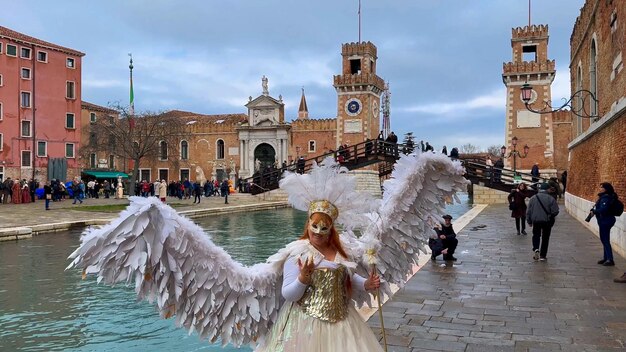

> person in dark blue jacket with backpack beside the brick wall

[{"left": 589, "top": 182, "right": 624, "bottom": 266}]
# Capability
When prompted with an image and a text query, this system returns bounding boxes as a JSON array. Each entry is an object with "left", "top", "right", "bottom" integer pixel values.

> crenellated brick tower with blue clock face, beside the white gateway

[{"left": 333, "top": 42, "right": 385, "bottom": 146}]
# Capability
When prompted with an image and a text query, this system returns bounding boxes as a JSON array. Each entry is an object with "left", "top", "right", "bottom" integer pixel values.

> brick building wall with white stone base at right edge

[{"left": 566, "top": 0, "right": 626, "bottom": 256}]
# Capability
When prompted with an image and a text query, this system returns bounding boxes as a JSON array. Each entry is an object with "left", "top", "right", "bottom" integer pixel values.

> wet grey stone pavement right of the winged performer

[{"left": 368, "top": 205, "right": 626, "bottom": 352}]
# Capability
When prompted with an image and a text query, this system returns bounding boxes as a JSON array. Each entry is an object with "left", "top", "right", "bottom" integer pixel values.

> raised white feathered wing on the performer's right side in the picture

[{"left": 342, "top": 152, "right": 468, "bottom": 304}]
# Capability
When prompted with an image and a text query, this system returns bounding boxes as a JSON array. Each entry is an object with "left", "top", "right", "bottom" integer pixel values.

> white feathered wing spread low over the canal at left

[{"left": 68, "top": 197, "right": 292, "bottom": 346}]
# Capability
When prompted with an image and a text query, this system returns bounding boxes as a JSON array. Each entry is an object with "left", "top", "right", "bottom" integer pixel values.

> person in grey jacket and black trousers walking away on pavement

[{"left": 526, "top": 183, "right": 559, "bottom": 261}]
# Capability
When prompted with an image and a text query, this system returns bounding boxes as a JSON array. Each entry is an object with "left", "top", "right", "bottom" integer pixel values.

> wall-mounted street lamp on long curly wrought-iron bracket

[{"left": 521, "top": 83, "right": 599, "bottom": 119}]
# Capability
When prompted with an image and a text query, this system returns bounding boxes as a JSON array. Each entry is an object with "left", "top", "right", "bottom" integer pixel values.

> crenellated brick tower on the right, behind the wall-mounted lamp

[{"left": 502, "top": 25, "right": 556, "bottom": 175}]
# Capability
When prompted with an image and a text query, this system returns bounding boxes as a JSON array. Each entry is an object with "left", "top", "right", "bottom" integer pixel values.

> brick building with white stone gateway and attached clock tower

[{"left": 126, "top": 42, "right": 384, "bottom": 181}]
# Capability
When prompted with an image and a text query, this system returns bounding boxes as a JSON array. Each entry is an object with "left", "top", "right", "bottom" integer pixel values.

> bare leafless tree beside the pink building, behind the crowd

[{"left": 81, "top": 106, "right": 186, "bottom": 195}]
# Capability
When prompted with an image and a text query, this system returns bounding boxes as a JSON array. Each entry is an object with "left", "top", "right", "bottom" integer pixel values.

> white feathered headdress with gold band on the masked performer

[{"left": 280, "top": 157, "right": 380, "bottom": 229}]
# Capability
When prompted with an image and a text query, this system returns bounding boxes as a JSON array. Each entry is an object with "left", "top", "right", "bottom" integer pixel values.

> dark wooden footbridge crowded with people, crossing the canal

[{"left": 244, "top": 140, "right": 546, "bottom": 194}]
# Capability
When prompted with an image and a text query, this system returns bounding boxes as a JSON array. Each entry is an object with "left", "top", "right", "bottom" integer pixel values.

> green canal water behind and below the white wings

[{"left": 0, "top": 196, "right": 471, "bottom": 352}]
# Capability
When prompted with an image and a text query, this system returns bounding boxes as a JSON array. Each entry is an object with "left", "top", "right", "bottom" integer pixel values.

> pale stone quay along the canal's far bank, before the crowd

[{"left": 0, "top": 194, "right": 287, "bottom": 236}]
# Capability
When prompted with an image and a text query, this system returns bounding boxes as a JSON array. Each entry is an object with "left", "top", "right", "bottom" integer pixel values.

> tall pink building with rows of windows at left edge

[{"left": 0, "top": 26, "right": 85, "bottom": 181}]
